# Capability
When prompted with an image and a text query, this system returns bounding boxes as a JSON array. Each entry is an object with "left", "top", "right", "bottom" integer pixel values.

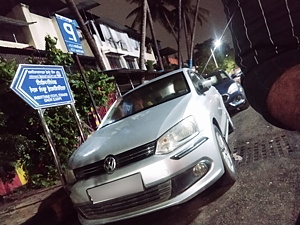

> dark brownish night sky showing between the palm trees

[{"left": 88, "top": 0, "right": 231, "bottom": 59}]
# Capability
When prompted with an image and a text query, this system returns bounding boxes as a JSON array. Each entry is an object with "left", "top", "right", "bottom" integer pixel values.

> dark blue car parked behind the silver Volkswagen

[{"left": 205, "top": 70, "right": 249, "bottom": 113}]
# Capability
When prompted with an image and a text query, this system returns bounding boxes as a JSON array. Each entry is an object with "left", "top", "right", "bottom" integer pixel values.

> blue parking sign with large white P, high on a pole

[{"left": 55, "top": 14, "right": 84, "bottom": 55}]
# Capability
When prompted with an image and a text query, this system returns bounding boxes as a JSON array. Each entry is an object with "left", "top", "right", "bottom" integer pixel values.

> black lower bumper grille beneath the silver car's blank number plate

[{"left": 77, "top": 180, "right": 172, "bottom": 219}]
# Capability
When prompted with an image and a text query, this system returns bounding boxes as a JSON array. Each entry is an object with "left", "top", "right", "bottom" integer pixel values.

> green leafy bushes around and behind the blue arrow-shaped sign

[{"left": 0, "top": 36, "right": 114, "bottom": 188}]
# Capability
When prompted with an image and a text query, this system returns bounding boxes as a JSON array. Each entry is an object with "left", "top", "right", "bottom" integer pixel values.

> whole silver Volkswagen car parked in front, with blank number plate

[{"left": 66, "top": 69, "right": 236, "bottom": 225}]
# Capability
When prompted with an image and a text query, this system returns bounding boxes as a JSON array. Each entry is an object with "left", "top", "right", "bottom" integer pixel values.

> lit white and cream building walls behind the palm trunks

[{"left": 2, "top": 4, "right": 156, "bottom": 69}]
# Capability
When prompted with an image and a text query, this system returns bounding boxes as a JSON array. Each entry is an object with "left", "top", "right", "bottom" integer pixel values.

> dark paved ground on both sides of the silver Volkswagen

[{"left": 0, "top": 108, "right": 300, "bottom": 225}]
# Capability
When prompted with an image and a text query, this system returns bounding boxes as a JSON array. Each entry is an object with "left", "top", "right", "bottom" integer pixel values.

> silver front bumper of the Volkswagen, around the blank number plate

[{"left": 71, "top": 134, "right": 224, "bottom": 225}]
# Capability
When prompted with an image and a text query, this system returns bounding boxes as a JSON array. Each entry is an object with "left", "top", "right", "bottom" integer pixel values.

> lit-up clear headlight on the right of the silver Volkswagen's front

[{"left": 156, "top": 116, "right": 199, "bottom": 155}]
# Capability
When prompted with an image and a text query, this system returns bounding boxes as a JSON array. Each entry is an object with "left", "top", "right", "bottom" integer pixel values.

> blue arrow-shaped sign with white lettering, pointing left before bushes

[{"left": 10, "top": 64, "right": 74, "bottom": 109}]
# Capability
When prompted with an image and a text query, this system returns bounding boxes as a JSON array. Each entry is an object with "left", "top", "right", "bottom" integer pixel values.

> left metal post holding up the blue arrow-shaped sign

[{"left": 38, "top": 109, "right": 66, "bottom": 187}]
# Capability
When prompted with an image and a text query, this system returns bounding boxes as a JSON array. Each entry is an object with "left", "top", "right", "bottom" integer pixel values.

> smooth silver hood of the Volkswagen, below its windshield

[{"left": 69, "top": 94, "right": 191, "bottom": 169}]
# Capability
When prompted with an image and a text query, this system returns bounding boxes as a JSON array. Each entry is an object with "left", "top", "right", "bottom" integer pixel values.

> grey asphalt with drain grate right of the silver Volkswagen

[{"left": 195, "top": 108, "right": 300, "bottom": 225}]
